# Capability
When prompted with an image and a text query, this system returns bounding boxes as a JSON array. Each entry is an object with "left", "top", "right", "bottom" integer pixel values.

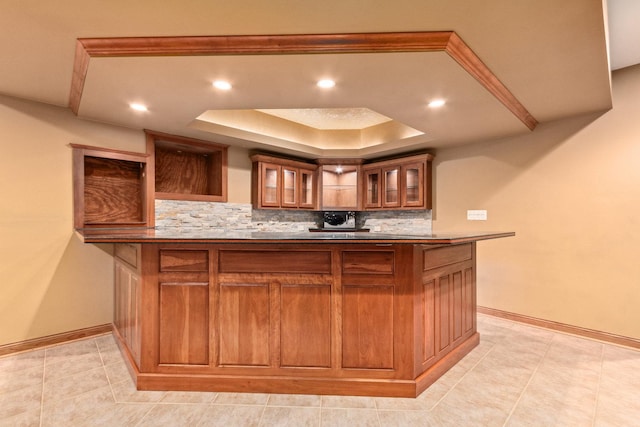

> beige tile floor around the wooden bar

[{"left": 0, "top": 315, "right": 640, "bottom": 427}]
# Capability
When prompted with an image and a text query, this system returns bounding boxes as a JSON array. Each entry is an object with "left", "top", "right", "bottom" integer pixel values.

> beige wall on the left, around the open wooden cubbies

[{"left": 0, "top": 96, "right": 251, "bottom": 345}]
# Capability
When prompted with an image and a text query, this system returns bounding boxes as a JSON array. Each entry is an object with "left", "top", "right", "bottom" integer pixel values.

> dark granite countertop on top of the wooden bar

[{"left": 76, "top": 228, "right": 515, "bottom": 244}]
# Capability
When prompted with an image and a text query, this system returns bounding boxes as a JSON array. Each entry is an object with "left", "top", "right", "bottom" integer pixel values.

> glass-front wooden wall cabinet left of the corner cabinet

[{"left": 251, "top": 154, "right": 318, "bottom": 209}]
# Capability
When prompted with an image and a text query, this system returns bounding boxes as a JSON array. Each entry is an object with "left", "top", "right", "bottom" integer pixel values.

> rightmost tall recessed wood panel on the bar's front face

[{"left": 342, "top": 286, "right": 394, "bottom": 369}]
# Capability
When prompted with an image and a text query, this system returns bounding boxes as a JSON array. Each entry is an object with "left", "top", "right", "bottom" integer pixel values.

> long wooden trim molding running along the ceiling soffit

[{"left": 69, "top": 31, "right": 538, "bottom": 130}]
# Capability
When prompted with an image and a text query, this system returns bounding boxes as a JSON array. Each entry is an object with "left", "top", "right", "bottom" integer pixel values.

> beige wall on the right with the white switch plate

[{"left": 433, "top": 66, "right": 640, "bottom": 339}]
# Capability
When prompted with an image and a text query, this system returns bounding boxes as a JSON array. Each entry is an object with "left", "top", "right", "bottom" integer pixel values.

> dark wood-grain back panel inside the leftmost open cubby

[{"left": 84, "top": 156, "right": 144, "bottom": 224}]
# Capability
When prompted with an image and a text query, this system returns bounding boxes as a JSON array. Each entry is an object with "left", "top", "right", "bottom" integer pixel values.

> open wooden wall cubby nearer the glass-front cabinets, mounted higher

[{"left": 145, "top": 130, "right": 228, "bottom": 202}]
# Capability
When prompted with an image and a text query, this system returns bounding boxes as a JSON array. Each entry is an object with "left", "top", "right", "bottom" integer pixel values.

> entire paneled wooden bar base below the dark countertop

[{"left": 115, "top": 241, "right": 479, "bottom": 397}]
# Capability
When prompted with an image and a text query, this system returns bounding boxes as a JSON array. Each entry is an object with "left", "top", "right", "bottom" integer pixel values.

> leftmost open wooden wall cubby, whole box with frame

[{"left": 71, "top": 144, "right": 153, "bottom": 228}]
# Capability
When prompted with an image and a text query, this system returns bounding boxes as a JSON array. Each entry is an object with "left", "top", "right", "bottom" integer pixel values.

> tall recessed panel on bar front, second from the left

[{"left": 217, "top": 284, "right": 270, "bottom": 366}]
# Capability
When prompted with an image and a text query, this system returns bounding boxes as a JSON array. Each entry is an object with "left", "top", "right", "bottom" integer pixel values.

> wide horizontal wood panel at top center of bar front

[{"left": 218, "top": 250, "right": 331, "bottom": 274}]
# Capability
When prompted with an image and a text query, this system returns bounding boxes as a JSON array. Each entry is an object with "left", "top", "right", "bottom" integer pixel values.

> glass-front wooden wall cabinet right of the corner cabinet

[{"left": 362, "top": 154, "right": 433, "bottom": 210}]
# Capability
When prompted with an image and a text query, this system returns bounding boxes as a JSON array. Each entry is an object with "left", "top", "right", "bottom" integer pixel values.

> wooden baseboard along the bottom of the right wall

[{"left": 478, "top": 306, "right": 640, "bottom": 350}]
